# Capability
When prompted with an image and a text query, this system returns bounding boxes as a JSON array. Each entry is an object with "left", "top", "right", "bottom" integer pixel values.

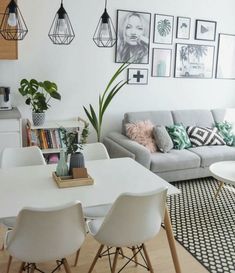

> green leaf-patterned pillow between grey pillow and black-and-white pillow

[{"left": 166, "top": 124, "right": 192, "bottom": 150}]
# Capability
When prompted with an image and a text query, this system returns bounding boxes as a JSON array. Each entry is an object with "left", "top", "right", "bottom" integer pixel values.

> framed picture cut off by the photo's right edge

[{"left": 215, "top": 33, "right": 235, "bottom": 80}]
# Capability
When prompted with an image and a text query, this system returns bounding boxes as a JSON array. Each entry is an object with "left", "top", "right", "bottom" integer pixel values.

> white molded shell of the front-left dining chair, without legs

[{"left": 6, "top": 201, "right": 86, "bottom": 263}]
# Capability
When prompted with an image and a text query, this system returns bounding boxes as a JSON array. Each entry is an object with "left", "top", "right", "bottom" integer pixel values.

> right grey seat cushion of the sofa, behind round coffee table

[{"left": 189, "top": 145, "right": 235, "bottom": 167}]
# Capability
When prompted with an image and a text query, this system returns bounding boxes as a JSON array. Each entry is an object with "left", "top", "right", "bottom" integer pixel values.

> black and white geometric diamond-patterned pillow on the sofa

[{"left": 186, "top": 126, "right": 226, "bottom": 147}]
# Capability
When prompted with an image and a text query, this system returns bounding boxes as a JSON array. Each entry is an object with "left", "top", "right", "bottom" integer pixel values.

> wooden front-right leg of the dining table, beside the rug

[{"left": 164, "top": 206, "right": 181, "bottom": 273}]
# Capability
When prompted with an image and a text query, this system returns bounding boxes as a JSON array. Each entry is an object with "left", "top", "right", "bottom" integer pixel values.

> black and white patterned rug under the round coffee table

[{"left": 168, "top": 178, "right": 235, "bottom": 273}]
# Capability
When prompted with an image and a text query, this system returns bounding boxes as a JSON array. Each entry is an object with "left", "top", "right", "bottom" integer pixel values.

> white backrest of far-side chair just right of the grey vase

[{"left": 82, "top": 142, "right": 109, "bottom": 160}]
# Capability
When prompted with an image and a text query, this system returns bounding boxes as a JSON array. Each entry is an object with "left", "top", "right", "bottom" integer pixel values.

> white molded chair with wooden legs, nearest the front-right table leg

[{"left": 88, "top": 188, "right": 167, "bottom": 273}]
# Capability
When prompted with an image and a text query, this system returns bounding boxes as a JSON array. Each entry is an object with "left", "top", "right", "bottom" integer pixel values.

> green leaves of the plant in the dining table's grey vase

[{"left": 59, "top": 122, "right": 89, "bottom": 155}]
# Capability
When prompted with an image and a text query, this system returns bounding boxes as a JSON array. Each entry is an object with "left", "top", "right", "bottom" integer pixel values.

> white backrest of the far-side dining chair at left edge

[{"left": 0, "top": 146, "right": 46, "bottom": 168}]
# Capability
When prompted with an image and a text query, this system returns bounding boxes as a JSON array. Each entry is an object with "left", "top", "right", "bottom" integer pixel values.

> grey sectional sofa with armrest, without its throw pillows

[{"left": 103, "top": 109, "right": 235, "bottom": 182}]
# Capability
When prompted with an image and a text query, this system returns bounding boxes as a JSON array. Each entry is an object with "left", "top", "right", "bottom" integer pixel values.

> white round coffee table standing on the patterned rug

[{"left": 209, "top": 161, "right": 235, "bottom": 197}]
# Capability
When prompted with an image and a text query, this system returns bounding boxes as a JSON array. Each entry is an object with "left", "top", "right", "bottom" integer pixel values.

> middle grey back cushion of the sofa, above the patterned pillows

[{"left": 172, "top": 109, "right": 215, "bottom": 127}]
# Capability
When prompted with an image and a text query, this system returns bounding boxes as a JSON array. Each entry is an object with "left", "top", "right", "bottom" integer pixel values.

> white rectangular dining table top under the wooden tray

[{"left": 0, "top": 158, "right": 180, "bottom": 218}]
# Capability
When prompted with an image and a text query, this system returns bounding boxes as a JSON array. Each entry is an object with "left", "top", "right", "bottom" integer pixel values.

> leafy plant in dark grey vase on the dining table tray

[{"left": 60, "top": 122, "right": 89, "bottom": 174}]
